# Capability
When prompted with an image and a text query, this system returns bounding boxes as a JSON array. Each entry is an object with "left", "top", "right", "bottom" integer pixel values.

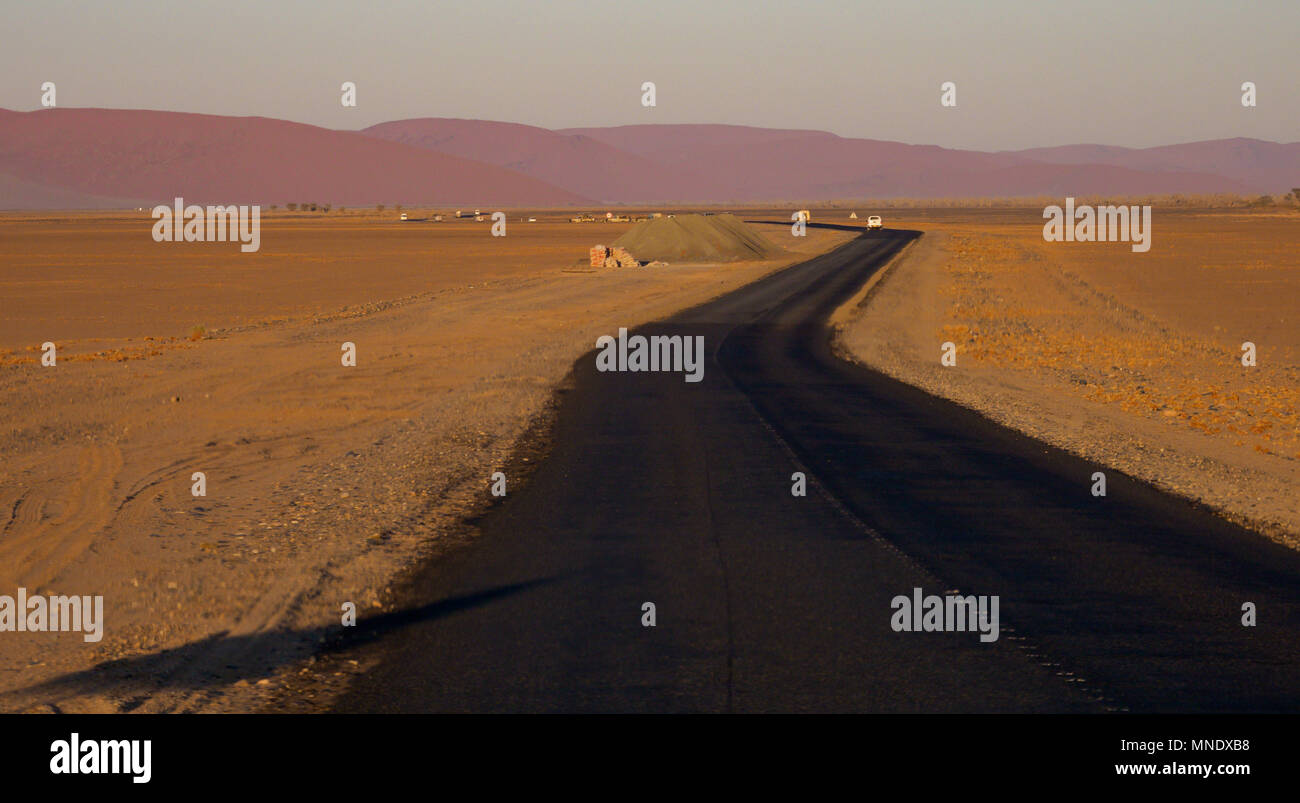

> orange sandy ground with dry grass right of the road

[{"left": 840, "top": 209, "right": 1300, "bottom": 546}]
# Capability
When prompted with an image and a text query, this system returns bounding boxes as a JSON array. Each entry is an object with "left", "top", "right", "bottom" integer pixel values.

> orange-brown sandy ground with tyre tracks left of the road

[{"left": 0, "top": 209, "right": 849, "bottom": 712}]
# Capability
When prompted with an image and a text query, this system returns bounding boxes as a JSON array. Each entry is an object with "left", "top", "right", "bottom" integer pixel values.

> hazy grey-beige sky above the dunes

[{"left": 0, "top": 0, "right": 1300, "bottom": 149}]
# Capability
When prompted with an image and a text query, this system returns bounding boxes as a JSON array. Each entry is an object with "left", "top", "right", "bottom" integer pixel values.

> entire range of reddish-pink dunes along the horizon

[{"left": 0, "top": 109, "right": 1300, "bottom": 208}]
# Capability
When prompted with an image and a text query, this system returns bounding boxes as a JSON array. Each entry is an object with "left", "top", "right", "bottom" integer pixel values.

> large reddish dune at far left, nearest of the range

[{"left": 0, "top": 109, "right": 589, "bottom": 208}]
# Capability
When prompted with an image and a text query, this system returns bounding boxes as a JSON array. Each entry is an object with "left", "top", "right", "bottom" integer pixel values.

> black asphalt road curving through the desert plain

[{"left": 337, "top": 230, "right": 1300, "bottom": 712}]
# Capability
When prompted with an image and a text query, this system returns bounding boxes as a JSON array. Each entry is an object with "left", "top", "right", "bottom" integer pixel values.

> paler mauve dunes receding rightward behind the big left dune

[{"left": 387, "top": 118, "right": 1291, "bottom": 203}]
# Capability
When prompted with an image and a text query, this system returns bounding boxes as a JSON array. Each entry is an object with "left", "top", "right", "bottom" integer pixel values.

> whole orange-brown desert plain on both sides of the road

[{"left": 0, "top": 205, "right": 1300, "bottom": 711}]
